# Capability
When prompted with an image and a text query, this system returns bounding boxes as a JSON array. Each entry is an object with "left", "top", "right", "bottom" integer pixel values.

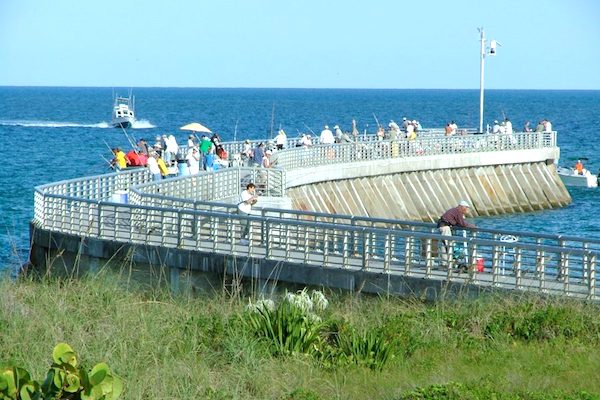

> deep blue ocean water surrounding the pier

[{"left": 0, "top": 87, "right": 600, "bottom": 269}]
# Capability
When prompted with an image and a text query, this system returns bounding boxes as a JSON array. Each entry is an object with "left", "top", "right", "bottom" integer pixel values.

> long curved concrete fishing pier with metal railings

[{"left": 30, "top": 132, "right": 600, "bottom": 300}]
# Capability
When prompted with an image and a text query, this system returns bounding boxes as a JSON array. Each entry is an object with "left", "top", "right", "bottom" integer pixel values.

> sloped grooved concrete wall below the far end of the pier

[{"left": 287, "top": 161, "right": 571, "bottom": 221}]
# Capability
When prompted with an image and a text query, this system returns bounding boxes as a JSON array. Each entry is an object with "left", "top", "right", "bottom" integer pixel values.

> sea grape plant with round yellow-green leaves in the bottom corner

[{"left": 0, "top": 343, "right": 123, "bottom": 400}]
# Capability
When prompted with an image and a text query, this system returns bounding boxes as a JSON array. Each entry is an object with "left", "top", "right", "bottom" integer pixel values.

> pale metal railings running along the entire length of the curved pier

[{"left": 34, "top": 133, "right": 600, "bottom": 299}]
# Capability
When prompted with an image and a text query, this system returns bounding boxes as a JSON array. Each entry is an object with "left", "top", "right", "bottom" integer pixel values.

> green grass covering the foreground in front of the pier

[{"left": 0, "top": 276, "right": 600, "bottom": 400}]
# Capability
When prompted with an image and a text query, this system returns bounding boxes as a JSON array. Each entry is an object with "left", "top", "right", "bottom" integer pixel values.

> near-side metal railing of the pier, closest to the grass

[{"left": 36, "top": 194, "right": 598, "bottom": 299}]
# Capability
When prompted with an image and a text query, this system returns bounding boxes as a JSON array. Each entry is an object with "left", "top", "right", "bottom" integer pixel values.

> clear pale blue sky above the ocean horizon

[{"left": 0, "top": 0, "right": 600, "bottom": 89}]
